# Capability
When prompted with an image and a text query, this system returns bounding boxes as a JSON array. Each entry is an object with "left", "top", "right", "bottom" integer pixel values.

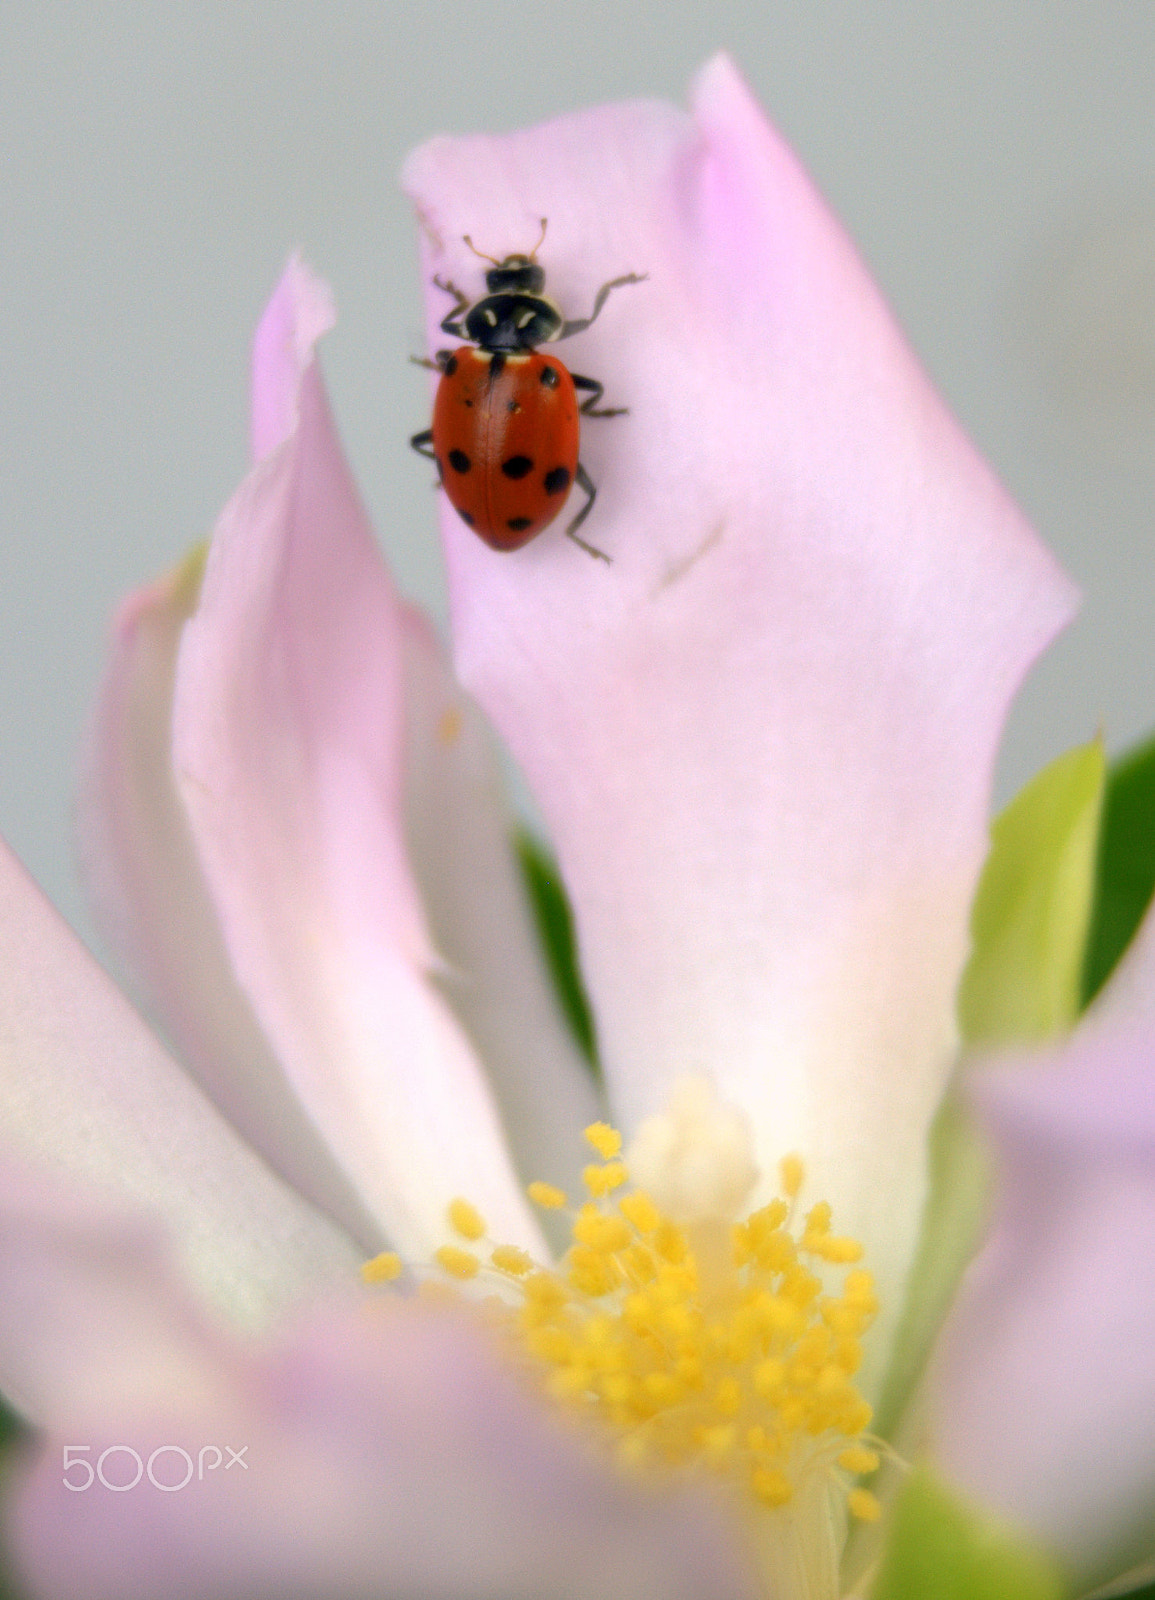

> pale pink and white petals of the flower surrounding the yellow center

[{"left": 0, "top": 58, "right": 1155, "bottom": 1600}]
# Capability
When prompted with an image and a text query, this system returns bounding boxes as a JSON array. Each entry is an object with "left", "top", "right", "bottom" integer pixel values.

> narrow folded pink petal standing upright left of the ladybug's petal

[{"left": 173, "top": 265, "right": 541, "bottom": 1259}]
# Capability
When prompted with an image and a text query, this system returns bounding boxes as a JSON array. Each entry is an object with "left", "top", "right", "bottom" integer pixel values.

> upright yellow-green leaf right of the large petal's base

[{"left": 958, "top": 739, "right": 1105, "bottom": 1045}]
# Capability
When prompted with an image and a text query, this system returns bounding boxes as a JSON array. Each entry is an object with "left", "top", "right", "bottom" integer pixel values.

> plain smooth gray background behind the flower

[{"left": 0, "top": 0, "right": 1155, "bottom": 931}]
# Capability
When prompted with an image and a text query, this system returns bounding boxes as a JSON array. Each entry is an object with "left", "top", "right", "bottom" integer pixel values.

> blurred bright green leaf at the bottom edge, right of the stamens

[{"left": 870, "top": 1467, "right": 1064, "bottom": 1600}]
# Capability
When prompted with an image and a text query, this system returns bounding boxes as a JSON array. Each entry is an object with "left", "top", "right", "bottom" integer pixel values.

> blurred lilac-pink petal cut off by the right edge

[{"left": 934, "top": 917, "right": 1155, "bottom": 1586}]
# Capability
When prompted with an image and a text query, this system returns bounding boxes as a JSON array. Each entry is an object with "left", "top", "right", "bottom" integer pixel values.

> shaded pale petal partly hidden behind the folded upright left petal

[{"left": 78, "top": 547, "right": 382, "bottom": 1253}]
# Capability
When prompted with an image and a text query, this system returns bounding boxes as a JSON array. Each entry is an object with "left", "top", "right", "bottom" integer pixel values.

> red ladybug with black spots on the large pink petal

[{"left": 410, "top": 218, "right": 645, "bottom": 562}]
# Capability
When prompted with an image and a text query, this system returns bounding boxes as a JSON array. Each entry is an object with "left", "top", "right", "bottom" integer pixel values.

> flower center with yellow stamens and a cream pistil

[{"left": 365, "top": 1085, "right": 880, "bottom": 1594}]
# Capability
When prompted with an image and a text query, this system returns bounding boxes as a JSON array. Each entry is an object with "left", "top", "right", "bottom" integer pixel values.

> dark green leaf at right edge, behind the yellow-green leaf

[{"left": 1083, "top": 739, "right": 1155, "bottom": 1005}]
